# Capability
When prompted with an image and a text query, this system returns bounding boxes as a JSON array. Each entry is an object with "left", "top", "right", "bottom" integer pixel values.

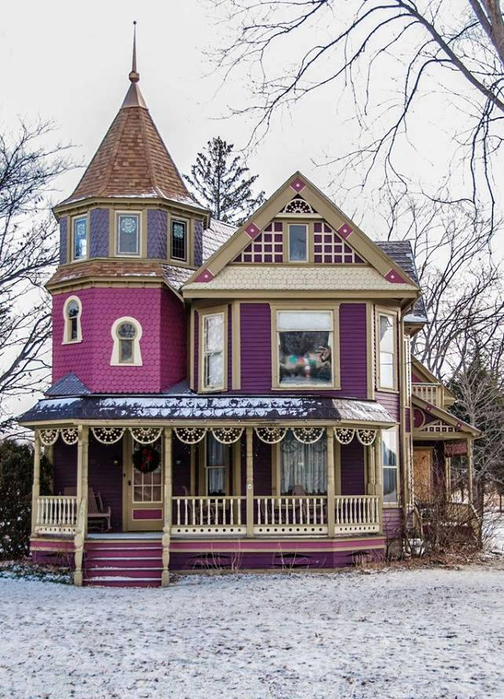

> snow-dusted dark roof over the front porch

[{"left": 20, "top": 393, "right": 395, "bottom": 427}]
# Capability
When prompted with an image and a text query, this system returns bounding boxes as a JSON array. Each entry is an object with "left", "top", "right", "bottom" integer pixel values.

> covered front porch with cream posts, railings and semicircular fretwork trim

[{"left": 22, "top": 399, "right": 395, "bottom": 584}]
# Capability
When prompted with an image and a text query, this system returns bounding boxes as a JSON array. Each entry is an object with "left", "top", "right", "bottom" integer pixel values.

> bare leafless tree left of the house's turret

[{"left": 0, "top": 123, "right": 69, "bottom": 430}]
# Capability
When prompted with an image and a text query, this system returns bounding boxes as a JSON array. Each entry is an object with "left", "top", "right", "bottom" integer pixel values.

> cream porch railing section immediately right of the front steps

[{"left": 171, "top": 496, "right": 247, "bottom": 536}]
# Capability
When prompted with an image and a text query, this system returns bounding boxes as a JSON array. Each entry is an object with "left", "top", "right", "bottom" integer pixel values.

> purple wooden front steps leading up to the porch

[{"left": 84, "top": 540, "right": 163, "bottom": 587}]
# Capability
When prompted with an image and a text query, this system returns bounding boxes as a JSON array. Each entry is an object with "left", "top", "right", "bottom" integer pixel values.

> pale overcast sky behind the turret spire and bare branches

[{"left": 0, "top": 0, "right": 502, "bottom": 424}]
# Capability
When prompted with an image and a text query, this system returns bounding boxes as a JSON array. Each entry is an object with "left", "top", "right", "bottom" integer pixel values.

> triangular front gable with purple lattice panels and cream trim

[{"left": 184, "top": 173, "right": 419, "bottom": 297}]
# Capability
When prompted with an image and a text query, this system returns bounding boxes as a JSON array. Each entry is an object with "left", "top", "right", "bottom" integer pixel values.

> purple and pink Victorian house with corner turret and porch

[{"left": 22, "top": 47, "right": 478, "bottom": 586}]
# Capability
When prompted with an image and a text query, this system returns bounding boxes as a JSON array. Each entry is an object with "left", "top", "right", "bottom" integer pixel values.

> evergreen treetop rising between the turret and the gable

[{"left": 185, "top": 136, "right": 265, "bottom": 225}]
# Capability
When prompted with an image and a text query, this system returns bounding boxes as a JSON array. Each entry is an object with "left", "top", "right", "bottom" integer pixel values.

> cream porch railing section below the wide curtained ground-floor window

[{"left": 254, "top": 495, "right": 327, "bottom": 536}]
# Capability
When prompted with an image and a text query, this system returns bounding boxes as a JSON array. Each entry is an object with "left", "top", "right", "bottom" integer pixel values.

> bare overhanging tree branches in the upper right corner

[{"left": 212, "top": 0, "right": 504, "bottom": 223}]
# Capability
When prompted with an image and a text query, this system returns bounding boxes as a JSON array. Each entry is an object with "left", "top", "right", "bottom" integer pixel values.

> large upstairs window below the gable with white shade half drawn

[{"left": 277, "top": 310, "right": 334, "bottom": 387}]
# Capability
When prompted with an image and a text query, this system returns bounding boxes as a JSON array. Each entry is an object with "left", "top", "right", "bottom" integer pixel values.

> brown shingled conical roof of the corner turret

[{"left": 63, "top": 78, "right": 197, "bottom": 205}]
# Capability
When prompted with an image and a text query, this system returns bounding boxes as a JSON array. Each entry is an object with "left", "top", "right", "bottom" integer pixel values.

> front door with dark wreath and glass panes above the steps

[{"left": 123, "top": 437, "right": 163, "bottom": 531}]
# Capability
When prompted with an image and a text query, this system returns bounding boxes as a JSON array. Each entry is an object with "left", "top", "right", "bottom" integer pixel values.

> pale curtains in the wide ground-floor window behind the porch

[{"left": 280, "top": 431, "right": 327, "bottom": 495}]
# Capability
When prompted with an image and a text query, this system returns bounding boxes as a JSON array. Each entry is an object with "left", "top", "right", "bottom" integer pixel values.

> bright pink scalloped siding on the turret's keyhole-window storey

[{"left": 53, "top": 288, "right": 187, "bottom": 393}]
